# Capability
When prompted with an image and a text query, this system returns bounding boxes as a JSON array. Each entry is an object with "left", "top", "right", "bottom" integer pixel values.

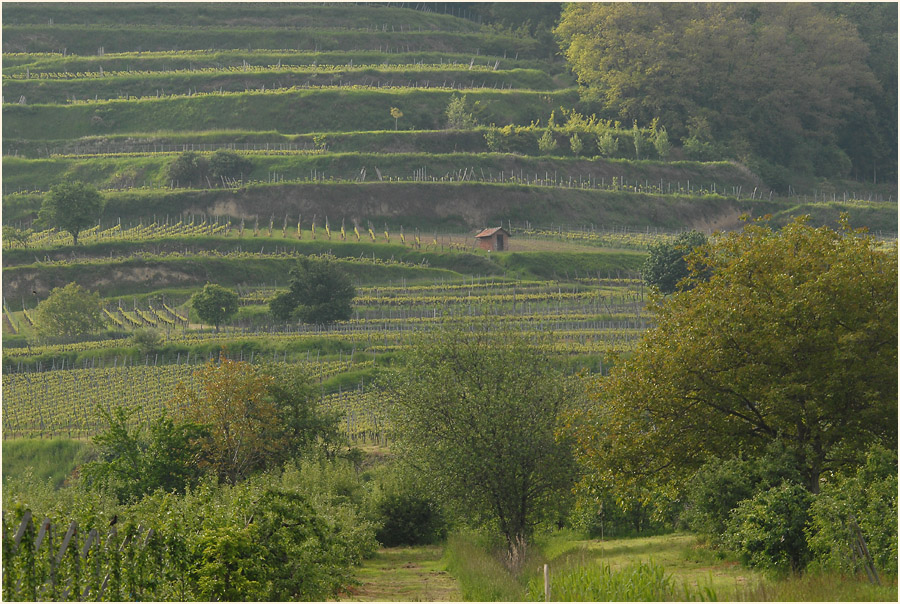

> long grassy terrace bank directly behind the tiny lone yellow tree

[{"left": 3, "top": 88, "right": 578, "bottom": 139}]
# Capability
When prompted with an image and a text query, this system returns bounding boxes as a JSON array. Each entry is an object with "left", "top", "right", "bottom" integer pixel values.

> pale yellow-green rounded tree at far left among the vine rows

[{"left": 34, "top": 283, "right": 104, "bottom": 339}]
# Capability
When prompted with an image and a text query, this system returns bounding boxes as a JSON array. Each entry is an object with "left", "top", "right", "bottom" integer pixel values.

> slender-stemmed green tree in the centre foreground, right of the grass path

[{"left": 389, "top": 324, "right": 573, "bottom": 547}]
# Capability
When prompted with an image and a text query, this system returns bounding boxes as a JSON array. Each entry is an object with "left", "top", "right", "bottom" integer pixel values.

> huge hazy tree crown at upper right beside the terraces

[{"left": 556, "top": 2, "right": 877, "bottom": 175}]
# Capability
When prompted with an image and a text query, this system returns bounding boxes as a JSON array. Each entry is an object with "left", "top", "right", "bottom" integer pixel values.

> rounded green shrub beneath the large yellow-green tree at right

[{"left": 725, "top": 482, "right": 813, "bottom": 574}]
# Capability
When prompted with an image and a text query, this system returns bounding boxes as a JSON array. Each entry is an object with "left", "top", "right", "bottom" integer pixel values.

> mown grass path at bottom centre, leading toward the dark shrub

[{"left": 339, "top": 545, "right": 460, "bottom": 602}]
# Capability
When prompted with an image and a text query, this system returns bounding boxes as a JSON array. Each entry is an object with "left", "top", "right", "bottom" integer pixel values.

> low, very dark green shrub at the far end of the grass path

[{"left": 375, "top": 493, "right": 447, "bottom": 547}]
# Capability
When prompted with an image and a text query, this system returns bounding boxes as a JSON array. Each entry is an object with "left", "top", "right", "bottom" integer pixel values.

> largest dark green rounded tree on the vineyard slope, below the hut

[{"left": 269, "top": 257, "right": 356, "bottom": 323}]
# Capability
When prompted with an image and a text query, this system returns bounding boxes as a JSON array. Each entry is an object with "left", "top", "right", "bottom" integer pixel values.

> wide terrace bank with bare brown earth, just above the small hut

[{"left": 5, "top": 182, "right": 781, "bottom": 230}]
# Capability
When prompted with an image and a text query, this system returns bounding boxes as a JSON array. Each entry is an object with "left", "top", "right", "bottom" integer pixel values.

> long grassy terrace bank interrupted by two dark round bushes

[{"left": 3, "top": 152, "right": 760, "bottom": 194}]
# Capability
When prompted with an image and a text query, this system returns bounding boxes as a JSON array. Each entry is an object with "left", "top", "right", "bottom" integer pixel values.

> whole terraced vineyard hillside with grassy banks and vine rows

[{"left": 2, "top": 3, "right": 896, "bottom": 436}]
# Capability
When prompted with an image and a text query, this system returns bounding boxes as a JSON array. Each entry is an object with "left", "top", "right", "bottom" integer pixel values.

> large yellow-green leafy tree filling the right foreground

[{"left": 575, "top": 217, "right": 897, "bottom": 492}]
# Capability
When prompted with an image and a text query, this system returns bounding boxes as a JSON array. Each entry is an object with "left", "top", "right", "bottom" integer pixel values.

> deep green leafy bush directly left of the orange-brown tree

[{"left": 82, "top": 407, "right": 205, "bottom": 502}]
